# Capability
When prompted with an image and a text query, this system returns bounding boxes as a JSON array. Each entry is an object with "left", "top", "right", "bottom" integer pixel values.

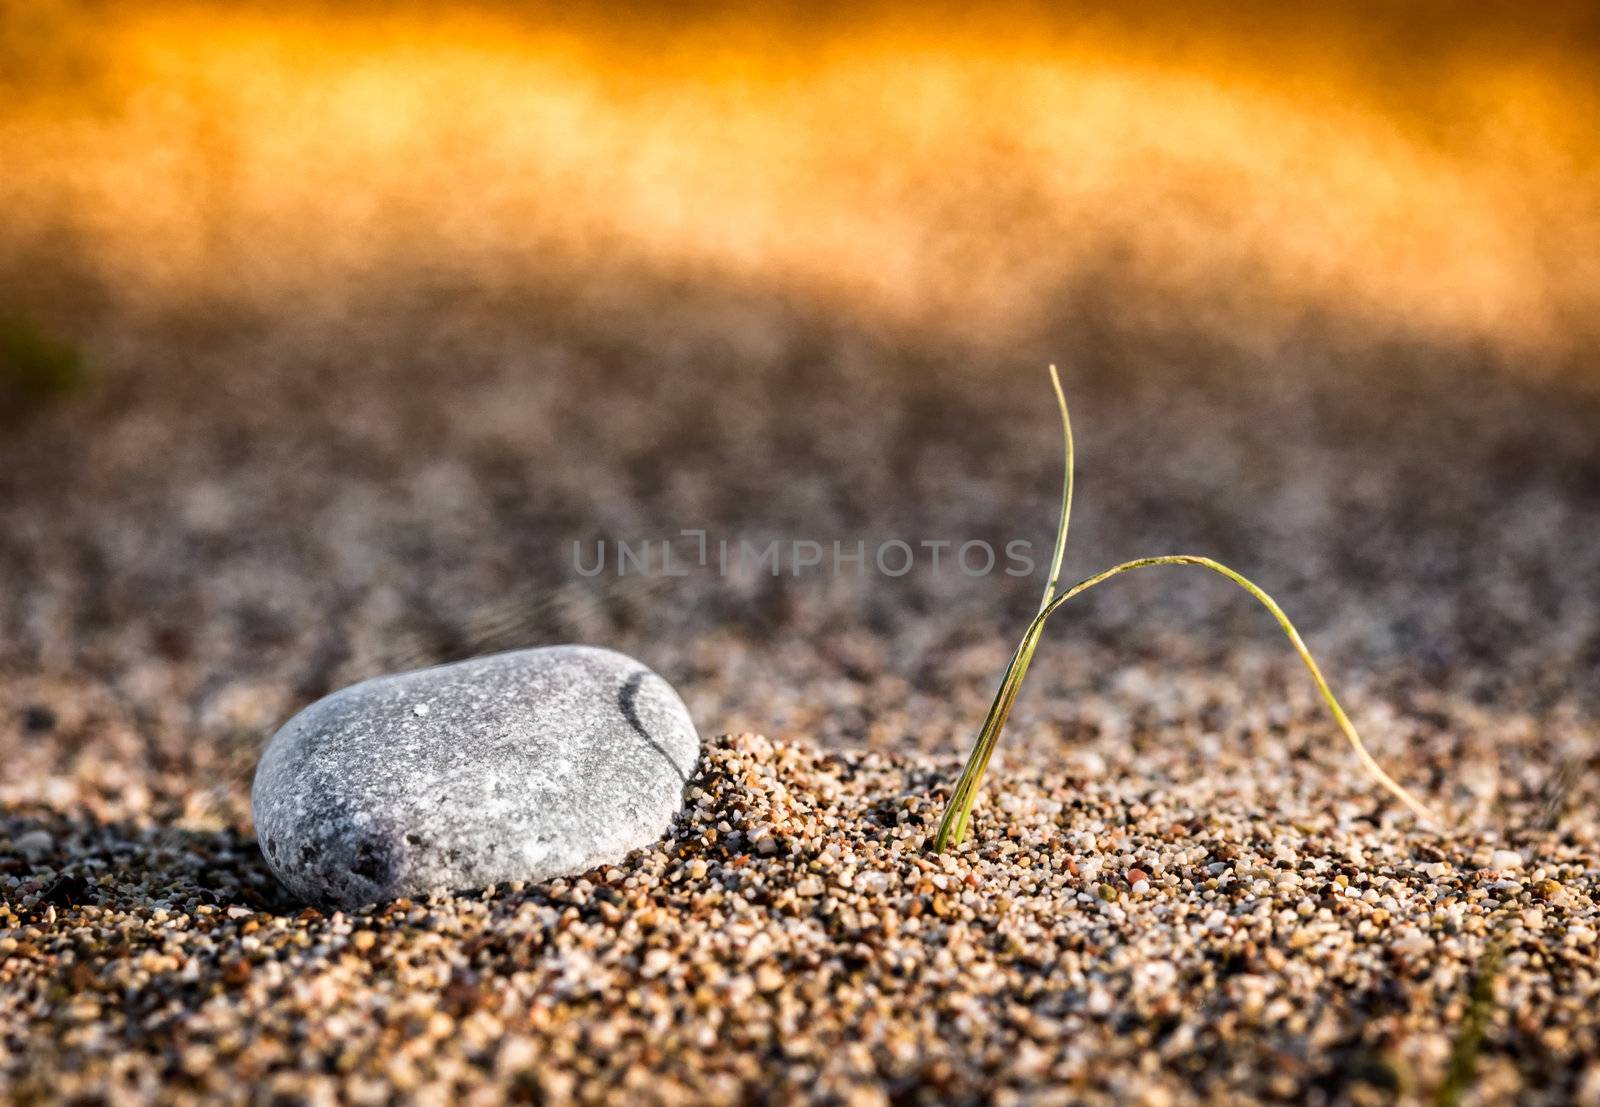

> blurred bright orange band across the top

[{"left": 0, "top": 3, "right": 1600, "bottom": 373}]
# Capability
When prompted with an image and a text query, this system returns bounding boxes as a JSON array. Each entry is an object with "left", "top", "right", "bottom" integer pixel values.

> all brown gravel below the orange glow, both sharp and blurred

[{"left": 0, "top": 283, "right": 1600, "bottom": 1104}]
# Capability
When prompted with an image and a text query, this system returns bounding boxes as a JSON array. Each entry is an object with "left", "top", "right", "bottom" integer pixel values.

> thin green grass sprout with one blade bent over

[{"left": 934, "top": 365, "right": 1434, "bottom": 853}]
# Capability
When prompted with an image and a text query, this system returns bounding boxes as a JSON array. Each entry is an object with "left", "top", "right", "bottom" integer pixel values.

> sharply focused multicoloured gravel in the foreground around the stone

[{"left": 9, "top": 734, "right": 1600, "bottom": 1104}]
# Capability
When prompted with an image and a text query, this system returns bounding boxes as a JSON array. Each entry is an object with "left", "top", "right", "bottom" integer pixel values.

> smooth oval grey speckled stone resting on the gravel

[{"left": 251, "top": 646, "right": 699, "bottom": 907}]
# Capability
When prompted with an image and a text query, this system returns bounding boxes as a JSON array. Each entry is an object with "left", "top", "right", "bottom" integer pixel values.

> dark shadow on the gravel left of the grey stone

[{"left": 0, "top": 805, "right": 304, "bottom": 920}]
